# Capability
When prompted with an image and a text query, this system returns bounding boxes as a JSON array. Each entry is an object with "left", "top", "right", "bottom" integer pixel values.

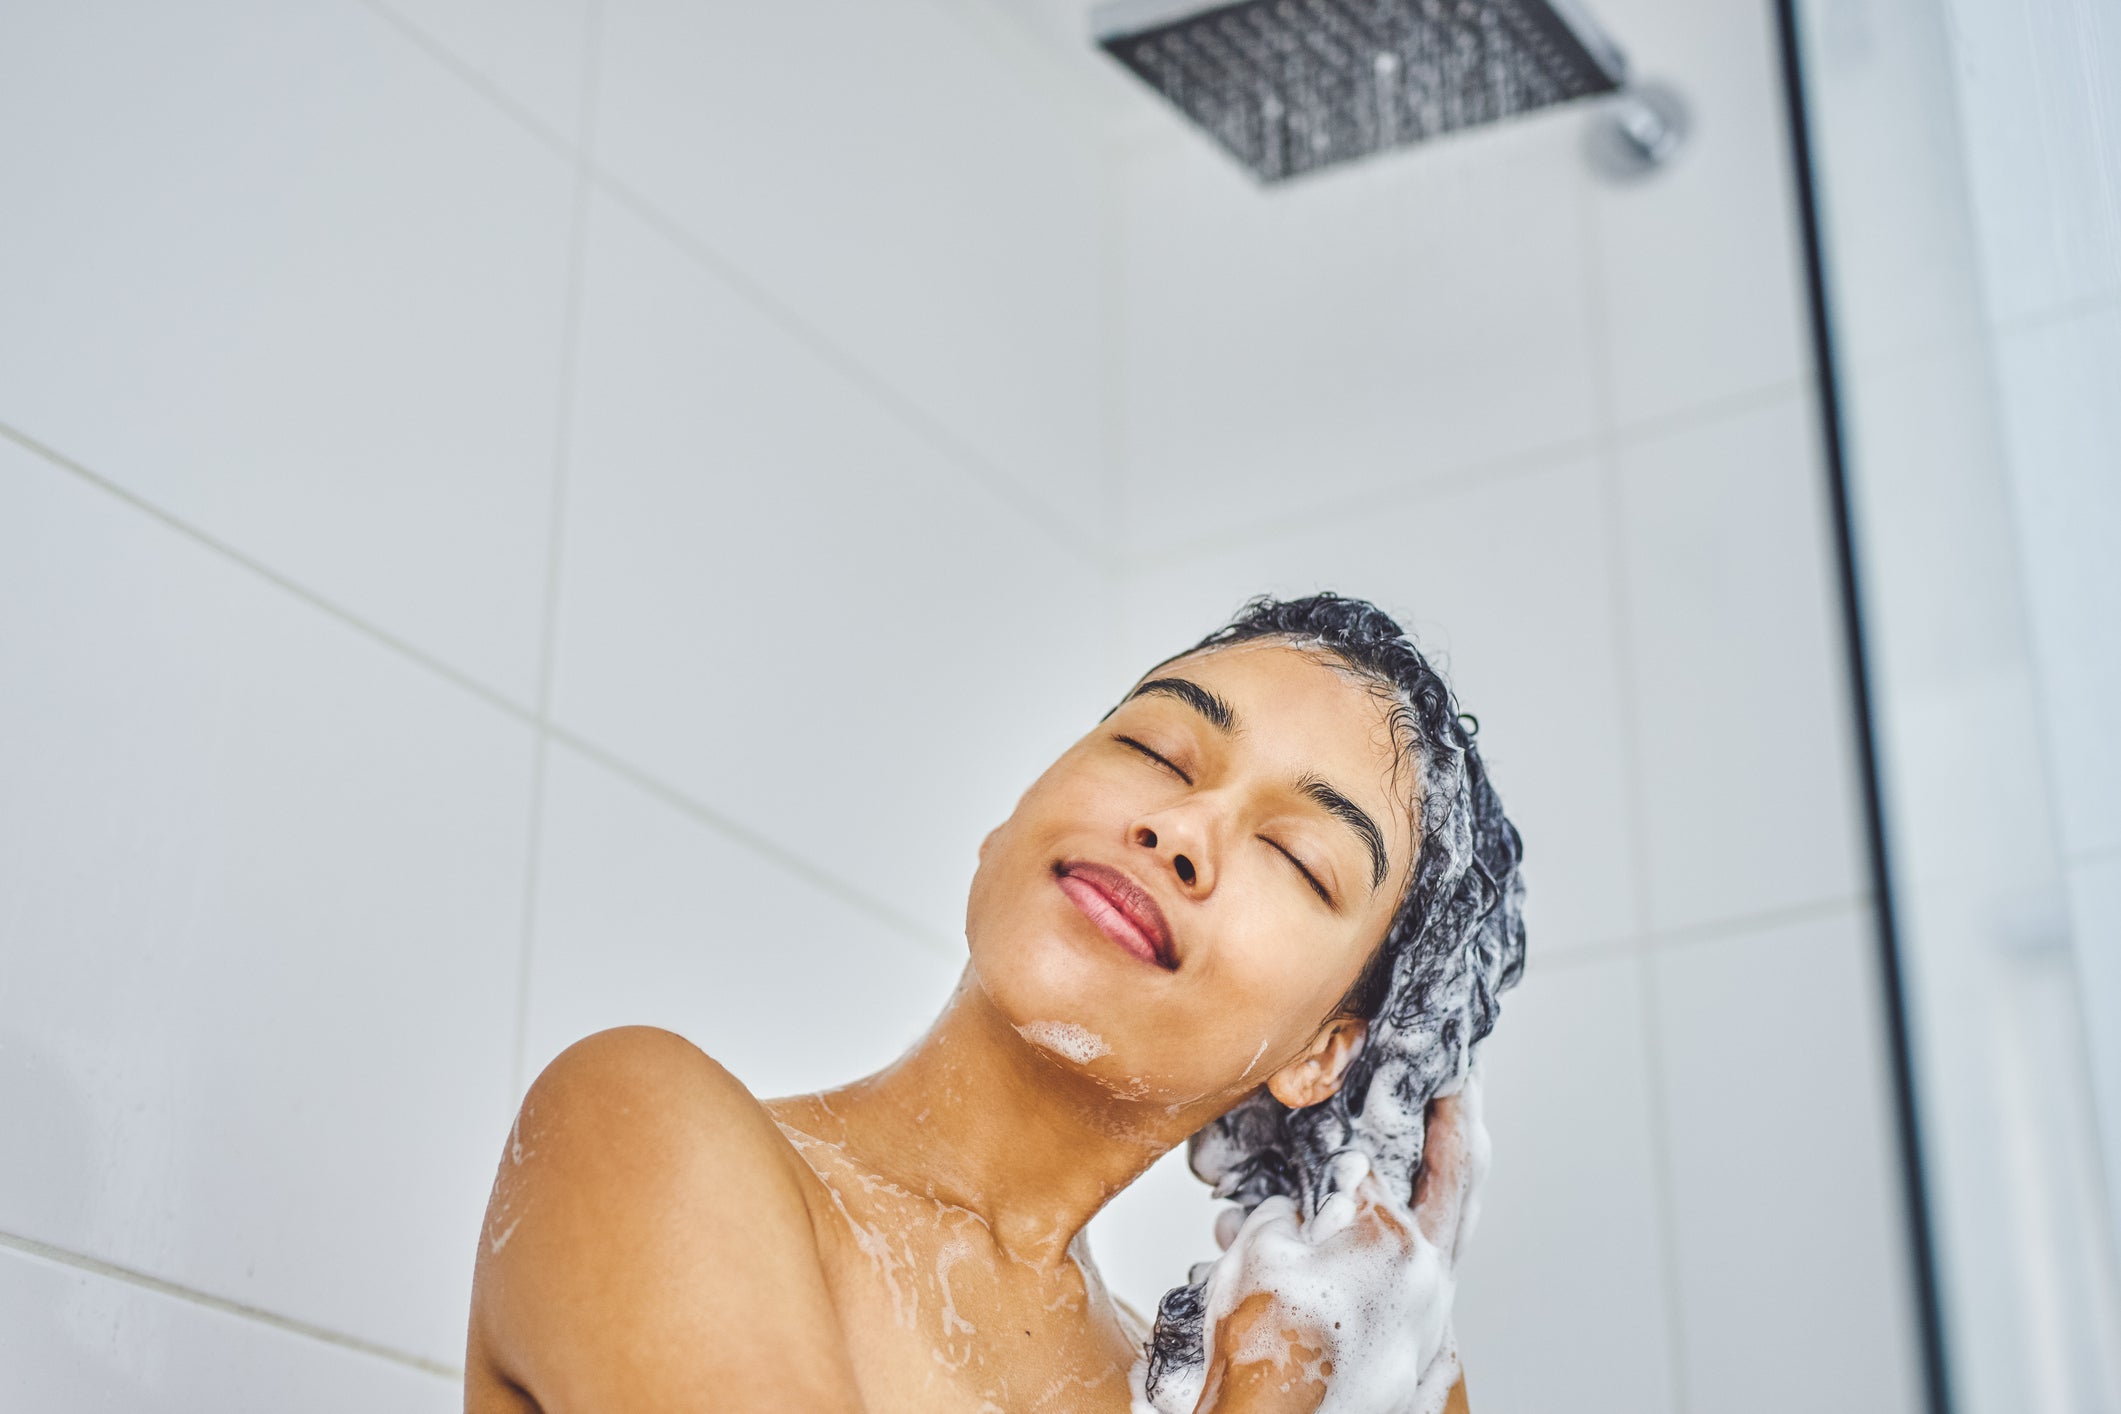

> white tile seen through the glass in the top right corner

[{"left": 1945, "top": 0, "right": 2121, "bottom": 320}]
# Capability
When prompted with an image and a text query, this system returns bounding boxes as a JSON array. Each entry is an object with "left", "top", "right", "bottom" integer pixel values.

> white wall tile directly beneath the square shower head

[{"left": 1120, "top": 114, "right": 1595, "bottom": 553}]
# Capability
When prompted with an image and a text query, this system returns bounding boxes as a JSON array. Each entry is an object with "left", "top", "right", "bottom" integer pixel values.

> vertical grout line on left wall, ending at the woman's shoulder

[{"left": 509, "top": 0, "right": 604, "bottom": 1100}]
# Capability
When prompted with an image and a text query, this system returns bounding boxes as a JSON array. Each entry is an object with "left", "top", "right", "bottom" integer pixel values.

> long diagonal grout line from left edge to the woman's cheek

[{"left": 0, "top": 422, "right": 957, "bottom": 983}]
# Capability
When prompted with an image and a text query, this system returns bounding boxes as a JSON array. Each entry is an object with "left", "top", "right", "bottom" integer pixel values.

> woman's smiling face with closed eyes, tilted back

[{"left": 965, "top": 640, "right": 1415, "bottom": 1104}]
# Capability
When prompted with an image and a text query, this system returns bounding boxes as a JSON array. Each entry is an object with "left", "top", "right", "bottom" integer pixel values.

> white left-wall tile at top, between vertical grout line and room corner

[{"left": 596, "top": 0, "right": 1105, "bottom": 536}]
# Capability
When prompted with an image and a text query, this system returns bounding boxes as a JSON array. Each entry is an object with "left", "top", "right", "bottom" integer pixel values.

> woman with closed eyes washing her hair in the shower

[{"left": 464, "top": 596, "right": 1523, "bottom": 1414}]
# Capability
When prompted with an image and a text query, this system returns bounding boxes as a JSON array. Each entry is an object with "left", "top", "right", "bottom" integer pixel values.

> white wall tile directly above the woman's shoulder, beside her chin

[{"left": 526, "top": 746, "right": 963, "bottom": 1096}]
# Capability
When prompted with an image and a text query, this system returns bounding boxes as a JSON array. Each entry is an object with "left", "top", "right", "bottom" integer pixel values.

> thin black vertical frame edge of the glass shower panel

[{"left": 1775, "top": 0, "right": 1951, "bottom": 1414}]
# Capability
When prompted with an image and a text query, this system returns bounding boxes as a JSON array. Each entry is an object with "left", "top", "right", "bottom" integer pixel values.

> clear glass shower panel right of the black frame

[{"left": 1794, "top": 0, "right": 2121, "bottom": 1414}]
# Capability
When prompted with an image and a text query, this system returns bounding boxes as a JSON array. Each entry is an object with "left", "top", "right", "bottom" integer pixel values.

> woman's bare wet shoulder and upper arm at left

[{"left": 467, "top": 1026, "right": 859, "bottom": 1414}]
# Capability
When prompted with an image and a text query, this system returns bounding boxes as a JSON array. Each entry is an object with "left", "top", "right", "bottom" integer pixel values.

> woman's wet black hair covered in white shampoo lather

[{"left": 1137, "top": 594, "right": 1525, "bottom": 1414}]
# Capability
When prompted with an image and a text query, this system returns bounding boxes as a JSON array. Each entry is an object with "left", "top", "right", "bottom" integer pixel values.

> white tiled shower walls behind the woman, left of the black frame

[{"left": 0, "top": 0, "right": 1942, "bottom": 1412}]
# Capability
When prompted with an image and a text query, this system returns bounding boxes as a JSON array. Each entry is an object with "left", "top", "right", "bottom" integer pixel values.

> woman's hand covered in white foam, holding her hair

[{"left": 1196, "top": 1075, "right": 1489, "bottom": 1414}]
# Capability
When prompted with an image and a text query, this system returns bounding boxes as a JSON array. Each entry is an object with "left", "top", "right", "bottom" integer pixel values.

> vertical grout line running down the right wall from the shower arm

[{"left": 1576, "top": 160, "right": 1688, "bottom": 1412}]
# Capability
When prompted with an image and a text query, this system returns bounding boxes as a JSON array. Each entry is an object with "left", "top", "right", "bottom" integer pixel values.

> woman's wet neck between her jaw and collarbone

[{"left": 797, "top": 967, "right": 1217, "bottom": 1266}]
